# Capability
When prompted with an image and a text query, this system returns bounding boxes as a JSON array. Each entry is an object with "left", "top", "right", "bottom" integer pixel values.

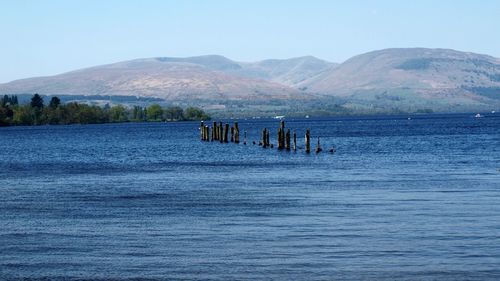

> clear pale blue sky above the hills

[{"left": 0, "top": 0, "right": 500, "bottom": 83}]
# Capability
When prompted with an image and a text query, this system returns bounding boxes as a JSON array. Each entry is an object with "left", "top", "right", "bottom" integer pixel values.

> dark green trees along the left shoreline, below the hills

[{"left": 0, "top": 94, "right": 210, "bottom": 126}]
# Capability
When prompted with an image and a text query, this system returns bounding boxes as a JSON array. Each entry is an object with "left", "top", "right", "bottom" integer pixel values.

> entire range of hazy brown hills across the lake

[{"left": 0, "top": 48, "right": 500, "bottom": 114}]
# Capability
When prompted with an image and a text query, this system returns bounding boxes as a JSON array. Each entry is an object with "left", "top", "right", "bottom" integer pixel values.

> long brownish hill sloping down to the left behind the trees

[{"left": 0, "top": 56, "right": 299, "bottom": 100}]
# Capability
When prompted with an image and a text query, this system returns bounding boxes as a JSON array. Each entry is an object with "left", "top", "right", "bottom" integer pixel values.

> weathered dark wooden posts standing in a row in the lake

[{"left": 200, "top": 120, "right": 334, "bottom": 153}]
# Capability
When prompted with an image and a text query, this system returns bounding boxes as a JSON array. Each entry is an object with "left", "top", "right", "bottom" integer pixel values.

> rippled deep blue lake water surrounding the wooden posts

[{"left": 0, "top": 114, "right": 500, "bottom": 280}]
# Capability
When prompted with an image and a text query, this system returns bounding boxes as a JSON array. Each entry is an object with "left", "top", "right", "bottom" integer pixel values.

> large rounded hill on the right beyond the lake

[{"left": 299, "top": 48, "right": 500, "bottom": 111}]
